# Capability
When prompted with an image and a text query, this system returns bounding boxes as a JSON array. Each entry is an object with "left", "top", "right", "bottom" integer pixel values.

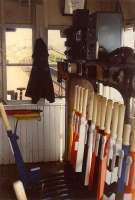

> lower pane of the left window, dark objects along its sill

[{"left": 7, "top": 66, "right": 31, "bottom": 100}]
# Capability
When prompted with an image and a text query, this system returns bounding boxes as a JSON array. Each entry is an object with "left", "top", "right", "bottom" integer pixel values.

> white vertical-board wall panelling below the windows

[{"left": 0, "top": 99, "right": 65, "bottom": 164}]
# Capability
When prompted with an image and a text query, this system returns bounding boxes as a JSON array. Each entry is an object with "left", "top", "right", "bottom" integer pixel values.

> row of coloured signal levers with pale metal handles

[{"left": 68, "top": 85, "right": 135, "bottom": 200}]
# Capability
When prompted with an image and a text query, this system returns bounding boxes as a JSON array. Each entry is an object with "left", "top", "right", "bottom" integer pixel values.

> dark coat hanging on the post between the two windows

[{"left": 25, "top": 38, "right": 55, "bottom": 103}]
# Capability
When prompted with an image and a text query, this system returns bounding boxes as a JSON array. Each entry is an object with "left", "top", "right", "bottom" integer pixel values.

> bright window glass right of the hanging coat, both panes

[{"left": 48, "top": 30, "right": 66, "bottom": 97}]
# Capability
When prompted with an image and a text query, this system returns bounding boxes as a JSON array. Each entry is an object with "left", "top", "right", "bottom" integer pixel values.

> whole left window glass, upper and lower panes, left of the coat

[{"left": 5, "top": 28, "right": 32, "bottom": 100}]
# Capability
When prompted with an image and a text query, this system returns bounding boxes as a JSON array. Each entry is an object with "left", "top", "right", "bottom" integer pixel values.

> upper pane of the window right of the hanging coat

[{"left": 48, "top": 30, "right": 66, "bottom": 64}]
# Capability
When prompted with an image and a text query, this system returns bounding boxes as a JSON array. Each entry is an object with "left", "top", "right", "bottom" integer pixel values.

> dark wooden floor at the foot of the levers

[{"left": 0, "top": 162, "right": 95, "bottom": 200}]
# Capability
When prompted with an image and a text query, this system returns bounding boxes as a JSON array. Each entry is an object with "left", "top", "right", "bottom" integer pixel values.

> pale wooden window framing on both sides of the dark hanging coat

[{"left": 0, "top": 24, "right": 67, "bottom": 105}]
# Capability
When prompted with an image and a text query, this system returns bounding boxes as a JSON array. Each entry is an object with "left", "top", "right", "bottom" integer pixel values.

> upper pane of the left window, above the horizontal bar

[{"left": 6, "top": 28, "right": 32, "bottom": 64}]
